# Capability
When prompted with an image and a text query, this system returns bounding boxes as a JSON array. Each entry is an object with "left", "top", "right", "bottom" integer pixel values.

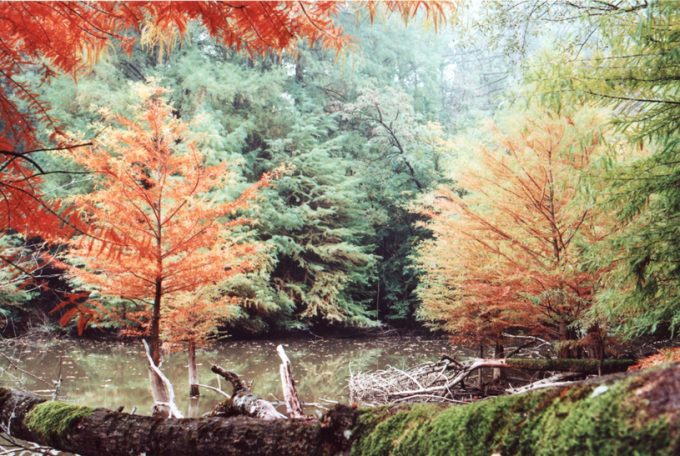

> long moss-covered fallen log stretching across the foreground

[{"left": 0, "top": 364, "right": 680, "bottom": 456}]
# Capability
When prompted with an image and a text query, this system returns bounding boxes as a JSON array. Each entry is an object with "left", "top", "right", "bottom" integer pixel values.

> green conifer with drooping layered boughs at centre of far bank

[{"left": 243, "top": 106, "right": 382, "bottom": 325}]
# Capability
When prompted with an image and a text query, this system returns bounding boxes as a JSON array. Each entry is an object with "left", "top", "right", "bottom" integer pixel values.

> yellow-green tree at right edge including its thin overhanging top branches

[{"left": 478, "top": 0, "right": 680, "bottom": 338}]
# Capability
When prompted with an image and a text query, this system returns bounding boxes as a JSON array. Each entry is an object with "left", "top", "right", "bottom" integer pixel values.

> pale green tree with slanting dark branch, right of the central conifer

[{"left": 343, "top": 85, "right": 448, "bottom": 322}]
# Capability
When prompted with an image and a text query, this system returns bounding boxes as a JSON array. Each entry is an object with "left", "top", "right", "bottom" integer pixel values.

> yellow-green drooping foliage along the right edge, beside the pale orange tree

[{"left": 537, "top": 0, "right": 680, "bottom": 336}]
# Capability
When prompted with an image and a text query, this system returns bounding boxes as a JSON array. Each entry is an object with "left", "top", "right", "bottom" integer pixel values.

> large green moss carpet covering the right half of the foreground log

[{"left": 352, "top": 380, "right": 678, "bottom": 456}]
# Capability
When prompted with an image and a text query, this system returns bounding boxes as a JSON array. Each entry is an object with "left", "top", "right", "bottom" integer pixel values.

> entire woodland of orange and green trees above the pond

[{"left": 0, "top": 0, "right": 680, "bottom": 454}]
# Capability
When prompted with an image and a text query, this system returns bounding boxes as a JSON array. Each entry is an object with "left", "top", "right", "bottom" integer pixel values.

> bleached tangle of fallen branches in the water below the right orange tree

[{"left": 349, "top": 357, "right": 633, "bottom": 405}]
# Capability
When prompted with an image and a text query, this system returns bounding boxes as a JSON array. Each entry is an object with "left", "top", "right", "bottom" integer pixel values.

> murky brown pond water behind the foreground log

[{"left": 0, "top": 337, "right": 462, "bottom": 414}]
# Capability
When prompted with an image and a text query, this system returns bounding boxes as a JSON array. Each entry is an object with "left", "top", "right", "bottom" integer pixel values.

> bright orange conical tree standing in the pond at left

[{"left": 61, "top": 85, "right": 270, "bottom": 414}]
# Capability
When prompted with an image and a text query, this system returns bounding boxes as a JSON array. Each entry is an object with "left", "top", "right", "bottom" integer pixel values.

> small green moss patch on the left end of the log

[{"left": 24, "top": 401, "right": 94, "bottom": 441}]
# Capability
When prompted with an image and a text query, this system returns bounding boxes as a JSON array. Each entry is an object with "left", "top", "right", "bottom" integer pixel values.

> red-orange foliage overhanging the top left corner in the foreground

[{"left": 0, "top": 0, "right": 455, "bottom": 237}]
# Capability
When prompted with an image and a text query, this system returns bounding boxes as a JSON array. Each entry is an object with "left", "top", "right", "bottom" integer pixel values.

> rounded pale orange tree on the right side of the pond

[{"left": 419, "top": 109, "right": 608, "bottom": 355}]
